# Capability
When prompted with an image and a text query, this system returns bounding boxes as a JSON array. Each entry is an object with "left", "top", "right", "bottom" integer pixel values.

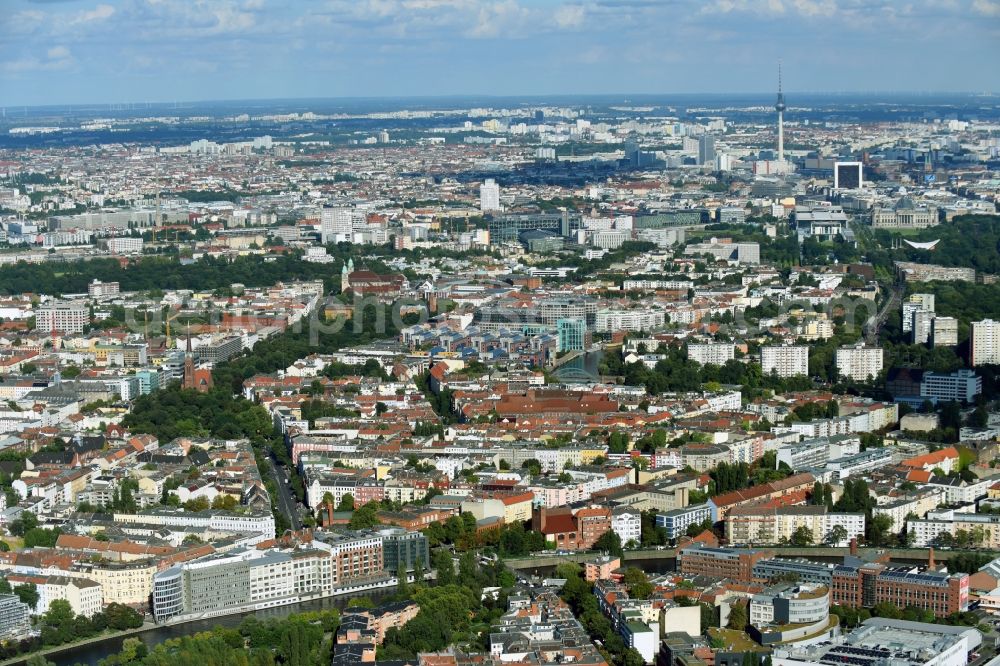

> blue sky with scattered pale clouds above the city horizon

[{"left": 0, "top": 0, "right": 1000, "bottom": 106}]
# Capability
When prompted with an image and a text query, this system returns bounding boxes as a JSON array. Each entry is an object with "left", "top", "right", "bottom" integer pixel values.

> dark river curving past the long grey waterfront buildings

[{"left": 16, "top": 587, "right": 396, "bottom": 666}]
